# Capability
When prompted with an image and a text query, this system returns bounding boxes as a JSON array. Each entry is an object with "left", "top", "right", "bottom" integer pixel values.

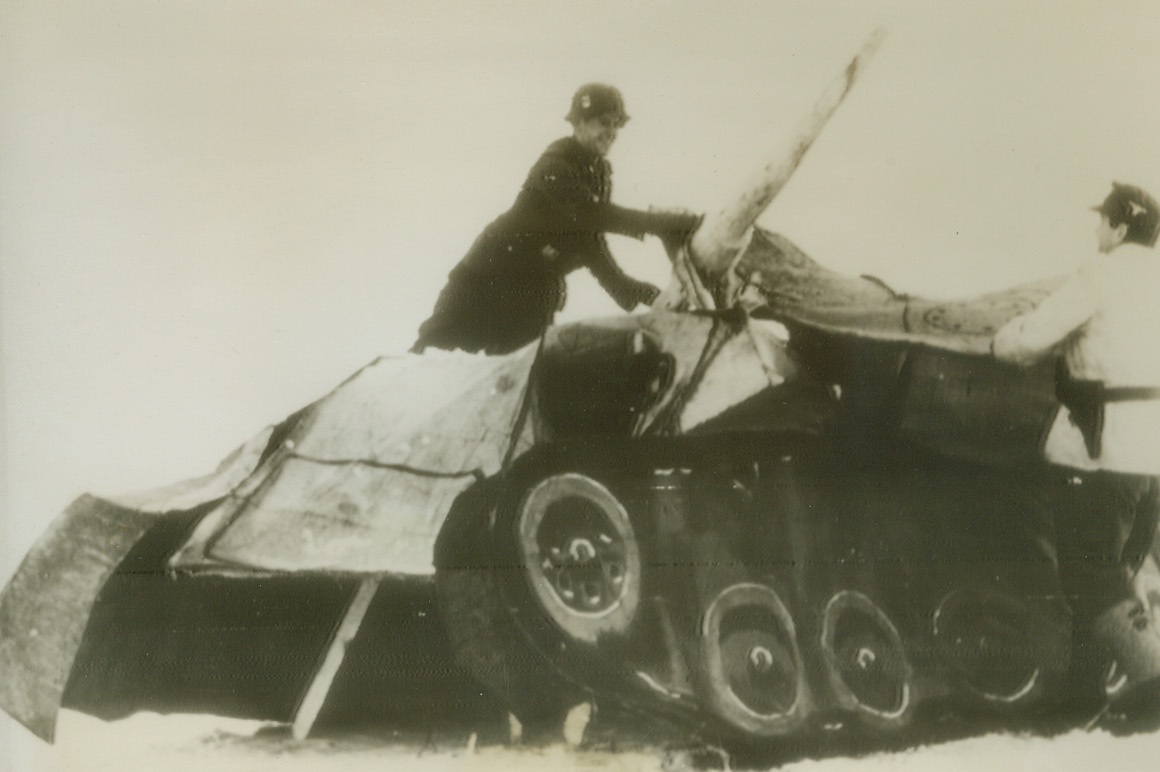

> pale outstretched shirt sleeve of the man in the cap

[{"left": 991, "top": 269, "right": 1096, "bottom": 365}]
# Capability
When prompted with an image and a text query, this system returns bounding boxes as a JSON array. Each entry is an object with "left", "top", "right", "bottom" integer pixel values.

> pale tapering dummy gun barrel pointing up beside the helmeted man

[{"left": 679, "top": 29, "right": 885, "bottom": 300}]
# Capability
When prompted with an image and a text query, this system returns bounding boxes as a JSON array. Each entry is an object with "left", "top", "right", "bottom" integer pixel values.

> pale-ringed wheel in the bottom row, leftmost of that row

[{"left": 701, "top": 583, "right": 805, "bottom": 737}]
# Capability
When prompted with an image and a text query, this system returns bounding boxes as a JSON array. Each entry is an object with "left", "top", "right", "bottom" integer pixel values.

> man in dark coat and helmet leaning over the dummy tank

[{"left": 412, "top": 83, "right": 701, "bottom": 354}]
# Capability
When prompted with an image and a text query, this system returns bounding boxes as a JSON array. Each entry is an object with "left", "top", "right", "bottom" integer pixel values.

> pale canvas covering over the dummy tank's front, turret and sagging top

[{"left": 0, "top": 230, "right": 1067, "bottom": 738}]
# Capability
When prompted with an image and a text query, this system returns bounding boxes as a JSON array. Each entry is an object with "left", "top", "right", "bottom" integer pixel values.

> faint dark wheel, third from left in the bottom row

[{"left": 933, "top": 590, "right": 1042, "bottom": 708}]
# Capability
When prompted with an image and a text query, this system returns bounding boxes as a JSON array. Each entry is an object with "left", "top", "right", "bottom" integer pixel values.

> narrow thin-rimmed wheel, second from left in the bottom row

[{"left": 821, "top": 590, "right": 913, "bottom": 727}]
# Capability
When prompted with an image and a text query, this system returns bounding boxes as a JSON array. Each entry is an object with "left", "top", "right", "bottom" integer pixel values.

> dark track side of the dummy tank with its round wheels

[{"left": 436, "top": 434, "right": 1113, "bottom": 745}]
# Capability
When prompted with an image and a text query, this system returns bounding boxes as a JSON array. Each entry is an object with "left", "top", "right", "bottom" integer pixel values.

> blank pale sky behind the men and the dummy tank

[{"left": 0, "top": 0, "right": 1160, "bottom": 755}]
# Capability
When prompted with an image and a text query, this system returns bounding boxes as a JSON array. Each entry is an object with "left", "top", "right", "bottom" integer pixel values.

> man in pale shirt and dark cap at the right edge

[{"left": 992, "top": 182, "right": 1160, "bottom": 721}]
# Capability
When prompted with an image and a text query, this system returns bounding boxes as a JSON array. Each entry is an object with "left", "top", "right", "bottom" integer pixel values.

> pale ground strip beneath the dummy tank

[{"left": 0, "top": 711, "right": 1160, "bottom": 772}]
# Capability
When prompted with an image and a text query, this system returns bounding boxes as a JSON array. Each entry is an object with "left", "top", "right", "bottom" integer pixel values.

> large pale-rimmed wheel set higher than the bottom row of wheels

[{"left": 516, "top": 473, "right": 640, "bottom": 643}]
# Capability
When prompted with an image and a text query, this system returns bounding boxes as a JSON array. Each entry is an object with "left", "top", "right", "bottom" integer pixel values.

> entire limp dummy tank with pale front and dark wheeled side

[{"left": 0, "top": 223, "right": 1155, "bottom": 743}]
